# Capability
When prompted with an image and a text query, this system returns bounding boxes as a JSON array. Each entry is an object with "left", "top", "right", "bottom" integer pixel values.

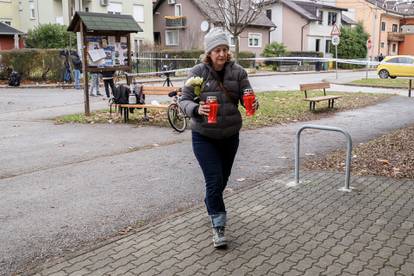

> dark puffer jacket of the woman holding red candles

[{"left": 180, "top": 62, "right": 251, "bottom": 139}]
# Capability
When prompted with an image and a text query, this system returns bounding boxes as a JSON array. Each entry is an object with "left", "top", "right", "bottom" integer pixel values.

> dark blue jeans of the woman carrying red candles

[{"left": 192, "top": 131, "right": 239, "bottom": 227}]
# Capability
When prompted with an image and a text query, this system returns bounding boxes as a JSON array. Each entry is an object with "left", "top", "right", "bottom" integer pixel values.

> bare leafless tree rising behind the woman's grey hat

[{"left": 199, "top": 0, "right": 267, "bottom": 61}]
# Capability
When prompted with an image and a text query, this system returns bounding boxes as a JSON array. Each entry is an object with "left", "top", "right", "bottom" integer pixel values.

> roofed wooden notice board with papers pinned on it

[{"left": 68, "top": 12, "right": 142, "bottom": 116}]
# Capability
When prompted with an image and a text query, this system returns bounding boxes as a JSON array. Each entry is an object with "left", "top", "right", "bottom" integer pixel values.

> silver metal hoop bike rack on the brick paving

[{"left": 289, "top": 125, "right": 352, "bottom": 192}]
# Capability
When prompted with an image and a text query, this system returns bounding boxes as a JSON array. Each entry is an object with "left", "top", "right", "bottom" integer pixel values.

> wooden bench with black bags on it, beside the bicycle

[{"left": 111, "top": 85, "right": 181, "bottom": 123}]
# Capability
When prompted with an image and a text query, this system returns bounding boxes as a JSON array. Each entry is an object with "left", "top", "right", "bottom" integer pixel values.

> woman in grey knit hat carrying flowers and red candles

[{"left": 180, "top": 28, "right": 258, "bottom": 248}]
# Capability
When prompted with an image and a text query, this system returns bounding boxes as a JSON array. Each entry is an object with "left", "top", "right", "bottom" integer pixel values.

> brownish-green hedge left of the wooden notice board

[{"left": 0, "top": 49, "right": 64, "bottom": 81}]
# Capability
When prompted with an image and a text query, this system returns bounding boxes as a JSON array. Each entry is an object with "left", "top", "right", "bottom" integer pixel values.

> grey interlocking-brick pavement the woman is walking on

[{"left": 32, "top": 172, "right": 414, "bottom": 276}]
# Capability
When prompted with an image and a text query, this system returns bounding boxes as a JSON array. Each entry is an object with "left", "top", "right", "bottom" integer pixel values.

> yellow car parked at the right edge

[{"left": 377, "top": 56, "right": 414, "bottom": 79}]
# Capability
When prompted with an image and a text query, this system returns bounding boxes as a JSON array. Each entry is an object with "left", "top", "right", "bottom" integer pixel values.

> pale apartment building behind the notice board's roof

[{"left": 0, "top": 0, "right": 154, "bottom": 50}]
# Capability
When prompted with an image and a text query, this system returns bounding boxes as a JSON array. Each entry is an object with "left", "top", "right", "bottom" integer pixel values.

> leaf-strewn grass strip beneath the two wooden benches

[{"left": 55, "top": 91, "right": 392, "bottom": 129}]
